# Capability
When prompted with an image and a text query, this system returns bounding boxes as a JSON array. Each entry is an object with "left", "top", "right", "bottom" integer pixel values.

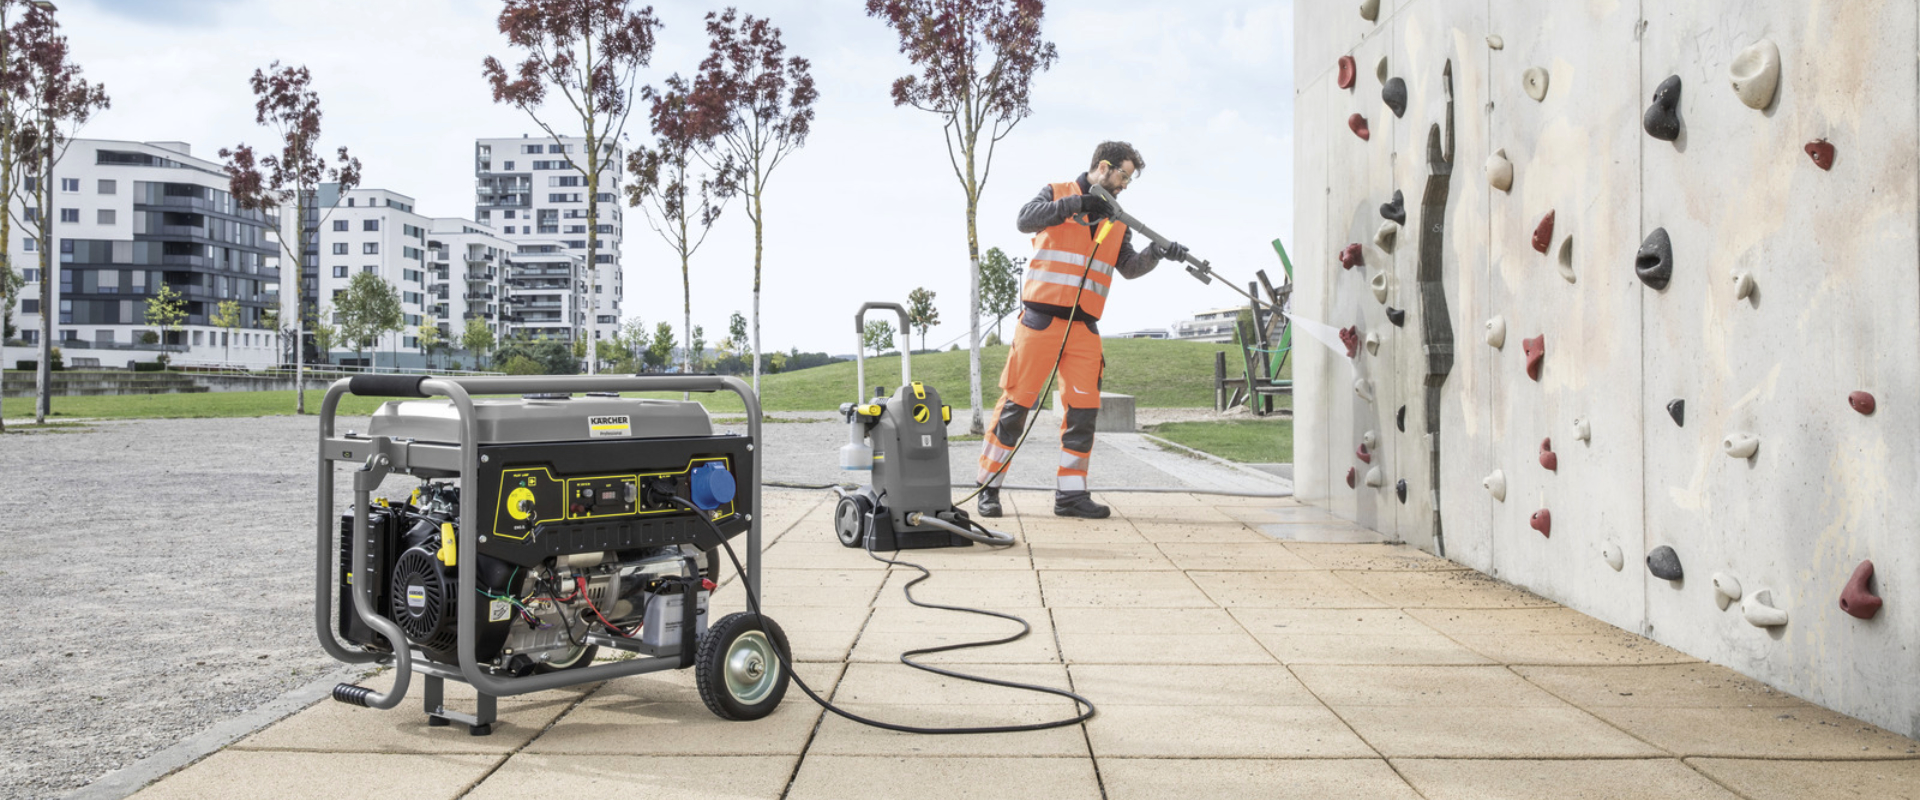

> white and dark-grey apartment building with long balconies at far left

[{"left": 0, "top": 138, "right": 280, "bottom": 366}]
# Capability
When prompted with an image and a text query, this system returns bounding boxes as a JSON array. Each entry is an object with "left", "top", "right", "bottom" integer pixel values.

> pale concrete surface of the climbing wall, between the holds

[{"left": 1294, "top": 0, "right": 1920, "bottom": 735}]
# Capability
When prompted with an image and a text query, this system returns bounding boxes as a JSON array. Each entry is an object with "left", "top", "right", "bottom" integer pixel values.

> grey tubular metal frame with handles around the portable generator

[{"left": 313, "top": 374, "right": 762, "bottom": 735}]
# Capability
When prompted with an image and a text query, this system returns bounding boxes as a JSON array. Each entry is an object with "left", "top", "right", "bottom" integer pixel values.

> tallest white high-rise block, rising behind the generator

[{"left": 474, "top": 136, "right": 626, "bottom": 340}]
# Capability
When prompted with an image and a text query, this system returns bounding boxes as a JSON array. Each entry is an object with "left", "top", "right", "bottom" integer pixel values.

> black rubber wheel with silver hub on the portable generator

[{"left": 693, "top": 612, "right": 793, "bottom": 721}]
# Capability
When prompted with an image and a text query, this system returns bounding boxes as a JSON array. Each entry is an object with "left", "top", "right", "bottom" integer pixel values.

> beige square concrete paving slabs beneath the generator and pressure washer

[{"left": 127, "top": 491, "right": 1920, "bottom": 800}]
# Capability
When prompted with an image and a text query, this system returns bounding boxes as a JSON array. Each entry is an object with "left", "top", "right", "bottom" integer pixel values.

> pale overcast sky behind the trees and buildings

[{"left": 58, "top": 0, "right": 1292, "bottom": 352}]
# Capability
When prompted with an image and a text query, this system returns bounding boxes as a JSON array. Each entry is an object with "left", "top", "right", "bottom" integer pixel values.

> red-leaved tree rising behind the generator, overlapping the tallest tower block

[{"left": 482, "top": 0, "right": 660, "bottom": 372}]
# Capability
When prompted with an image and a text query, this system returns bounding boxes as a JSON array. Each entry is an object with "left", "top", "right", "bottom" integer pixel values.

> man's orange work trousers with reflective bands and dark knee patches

[{"left": 975, "top": 311, "right": 1106, "bottom": 501}]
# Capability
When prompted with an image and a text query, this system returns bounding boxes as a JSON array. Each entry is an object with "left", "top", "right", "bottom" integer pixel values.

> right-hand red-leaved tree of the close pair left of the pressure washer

[{"left": 693, "top": 8, "right": 820, "bottom": 391}]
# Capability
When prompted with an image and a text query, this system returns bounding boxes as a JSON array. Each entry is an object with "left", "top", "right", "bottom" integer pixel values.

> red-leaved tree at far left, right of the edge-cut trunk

[{"left": 4, "top": 4, "right": 111, "bottom": 424}]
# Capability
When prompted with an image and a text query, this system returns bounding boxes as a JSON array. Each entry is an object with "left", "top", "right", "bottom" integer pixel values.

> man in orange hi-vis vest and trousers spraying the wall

[{"left": 975, "top": 142, "right": 1187, "bottom": 520}]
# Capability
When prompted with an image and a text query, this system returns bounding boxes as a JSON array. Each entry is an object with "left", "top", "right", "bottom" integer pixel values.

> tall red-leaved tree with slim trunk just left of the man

[{"left": 866, "top": 0, "right": 1058, "bottom": 434}]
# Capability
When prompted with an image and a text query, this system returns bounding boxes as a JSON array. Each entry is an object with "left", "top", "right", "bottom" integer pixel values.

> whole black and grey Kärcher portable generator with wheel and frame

[{"left": 315, "top": 376, "right": 791, "bottom": 735}]
